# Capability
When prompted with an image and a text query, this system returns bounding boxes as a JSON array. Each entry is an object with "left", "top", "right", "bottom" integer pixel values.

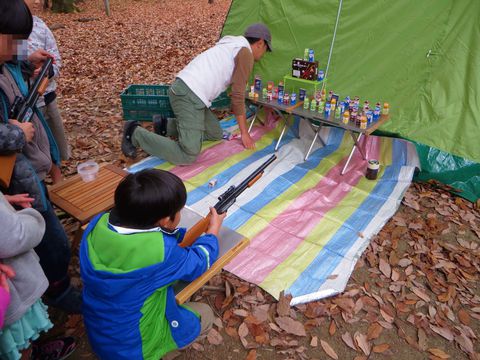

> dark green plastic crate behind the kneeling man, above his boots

[{"left": 120, "top": 84, "right": 175, "bottom": 121}]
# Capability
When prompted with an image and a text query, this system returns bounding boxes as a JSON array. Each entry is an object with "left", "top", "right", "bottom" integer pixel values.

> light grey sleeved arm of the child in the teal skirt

[{"left": 0, "top": 195, "right": 45, "bottom": 258}]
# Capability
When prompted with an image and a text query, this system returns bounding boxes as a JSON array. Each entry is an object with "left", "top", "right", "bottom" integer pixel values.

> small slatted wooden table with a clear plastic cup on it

[{"left": 48, "top": 165, "right": 128, "bottom": 249}]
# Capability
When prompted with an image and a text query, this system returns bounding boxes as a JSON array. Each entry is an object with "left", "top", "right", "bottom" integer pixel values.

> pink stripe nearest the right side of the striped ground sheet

[{"left": 225, "top": 134, "right": 381, "bottom": 284}]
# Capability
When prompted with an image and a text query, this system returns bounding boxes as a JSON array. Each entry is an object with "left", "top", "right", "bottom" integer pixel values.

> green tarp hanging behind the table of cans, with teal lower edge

[{"left": 222, "top": 0, "right": 480, "bottom": 201}]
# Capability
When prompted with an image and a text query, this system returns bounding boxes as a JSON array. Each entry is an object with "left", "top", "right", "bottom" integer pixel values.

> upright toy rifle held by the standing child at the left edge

[{"left": 0, "top": 58, "right": 53, "bottom": 188}]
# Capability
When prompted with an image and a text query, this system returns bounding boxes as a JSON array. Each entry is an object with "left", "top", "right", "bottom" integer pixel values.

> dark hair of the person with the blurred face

[{"left": 0, "top": 0, "right": 33, "bottom": 39}]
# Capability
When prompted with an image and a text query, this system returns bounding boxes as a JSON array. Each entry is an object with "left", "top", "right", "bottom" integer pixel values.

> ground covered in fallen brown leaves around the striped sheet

[{"left": 34, "top": 0, "right": 480, "bottom": 360}]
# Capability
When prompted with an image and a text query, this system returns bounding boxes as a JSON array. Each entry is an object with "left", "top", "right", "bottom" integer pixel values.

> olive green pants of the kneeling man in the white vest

[{"left": 132, "top": 78, "right": 222, "bottom": 164}]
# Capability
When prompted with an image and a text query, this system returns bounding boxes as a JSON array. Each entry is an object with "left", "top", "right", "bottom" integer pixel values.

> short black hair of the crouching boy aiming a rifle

[{"left": 111, "top": 169, "right": 187, "bottom": 229}]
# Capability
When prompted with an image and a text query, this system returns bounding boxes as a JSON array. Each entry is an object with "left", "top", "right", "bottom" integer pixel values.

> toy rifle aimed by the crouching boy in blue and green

[{"left": 180, "top": 155, "right": 277, "bottom": 247}]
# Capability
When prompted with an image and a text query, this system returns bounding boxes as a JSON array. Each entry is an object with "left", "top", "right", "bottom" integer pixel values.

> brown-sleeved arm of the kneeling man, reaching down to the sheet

[{"left": 232, "top": 48, "right": 255, "bottom": 149}]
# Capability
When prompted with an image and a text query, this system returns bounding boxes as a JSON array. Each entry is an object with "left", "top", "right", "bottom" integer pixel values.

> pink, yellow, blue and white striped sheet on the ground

[{"left": 129, "top": 119, "right": 418, "bottom": 305}]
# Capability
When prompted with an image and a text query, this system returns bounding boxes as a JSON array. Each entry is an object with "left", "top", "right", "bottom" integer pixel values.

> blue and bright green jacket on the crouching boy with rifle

[{"left": 80, "top": 213, "right": 218, "bottom": 360}]
